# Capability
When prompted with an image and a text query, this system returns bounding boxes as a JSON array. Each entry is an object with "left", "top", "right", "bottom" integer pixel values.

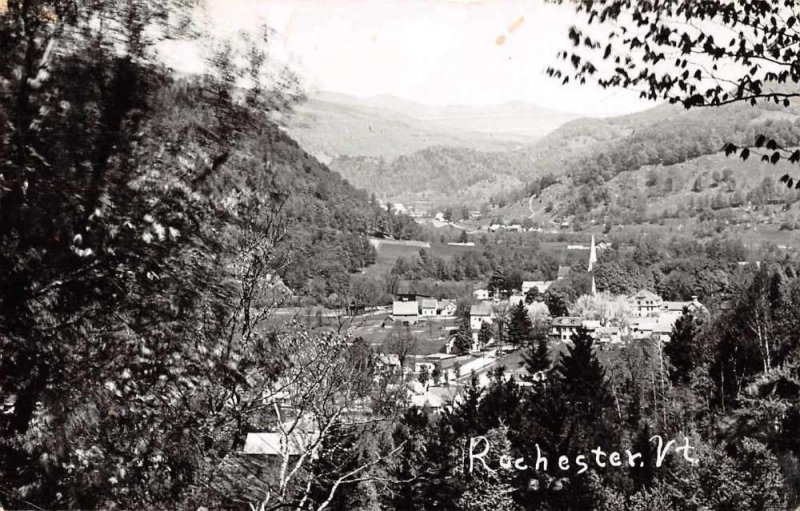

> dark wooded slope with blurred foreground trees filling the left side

[{"left": 0, "top": 4, "right": 416, "bottom": 509}]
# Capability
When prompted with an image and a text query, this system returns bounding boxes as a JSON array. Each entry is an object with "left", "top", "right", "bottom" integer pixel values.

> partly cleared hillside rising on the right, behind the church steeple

[{"left": 487, "top": 100, "right": 800, "bottom": 230}]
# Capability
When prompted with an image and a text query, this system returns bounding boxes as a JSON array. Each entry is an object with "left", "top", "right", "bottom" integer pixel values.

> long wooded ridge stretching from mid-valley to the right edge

[{"left": 331, "top": 95, "right": 800, "bottom": 223}]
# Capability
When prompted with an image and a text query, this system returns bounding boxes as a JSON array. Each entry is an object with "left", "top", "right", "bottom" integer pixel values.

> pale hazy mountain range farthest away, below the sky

[{"left": 288, "top": 93, "right": 575, "bottom": 162}]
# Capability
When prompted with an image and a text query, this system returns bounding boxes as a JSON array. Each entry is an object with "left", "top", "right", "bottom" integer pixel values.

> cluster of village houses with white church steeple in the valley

[{"left": 372, "top": 236, "right": 707, "bottom": 413}]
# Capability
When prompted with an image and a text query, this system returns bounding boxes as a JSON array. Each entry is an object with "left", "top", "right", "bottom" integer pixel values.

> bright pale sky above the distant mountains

[{"left": 181, "top": 0, "right": 653, "bottom": 116}]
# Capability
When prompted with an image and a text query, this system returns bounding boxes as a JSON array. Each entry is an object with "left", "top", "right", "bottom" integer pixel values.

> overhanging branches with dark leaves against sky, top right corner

[{"left": 547, "top": 0, "right": 800, "bottom": 188}]
